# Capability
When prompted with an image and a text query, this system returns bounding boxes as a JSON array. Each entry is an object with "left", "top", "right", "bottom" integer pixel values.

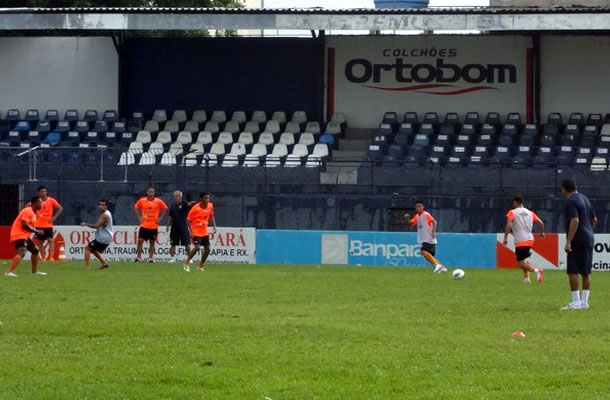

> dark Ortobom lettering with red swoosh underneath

[{"left": 344, "top": 58, "right": 517, "bottom": 96}]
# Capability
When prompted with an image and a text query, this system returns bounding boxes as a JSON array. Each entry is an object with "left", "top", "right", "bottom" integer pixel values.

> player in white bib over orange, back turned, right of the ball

[{"left": 503, "top": 196, "right": 544, "bottom": 284}]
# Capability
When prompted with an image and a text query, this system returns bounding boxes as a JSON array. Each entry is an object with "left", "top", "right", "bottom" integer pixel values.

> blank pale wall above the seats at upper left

[{"left": 0, "top": 37, "right": 118, "bottom": 117}]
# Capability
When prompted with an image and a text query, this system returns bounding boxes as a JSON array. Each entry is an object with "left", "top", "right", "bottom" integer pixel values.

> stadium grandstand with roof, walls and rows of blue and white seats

[{"left": 0, "top": 6, "right": 610, "bottom": 232}]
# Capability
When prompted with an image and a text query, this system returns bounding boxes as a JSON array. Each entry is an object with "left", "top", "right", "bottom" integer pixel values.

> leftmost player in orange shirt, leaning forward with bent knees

[{"left": 4, "top": 197, "right": 46, "bottom": 278}]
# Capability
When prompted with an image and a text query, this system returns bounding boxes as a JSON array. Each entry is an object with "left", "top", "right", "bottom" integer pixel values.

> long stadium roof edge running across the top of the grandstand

[{"left": 0, "top": 7, "right": 610, "bottom": 31}]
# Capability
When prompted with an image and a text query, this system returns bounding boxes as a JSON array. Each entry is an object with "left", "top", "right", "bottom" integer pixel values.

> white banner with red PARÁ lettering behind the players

[{"left": 54, "top": 225, "right": 256, "bottom": 264}]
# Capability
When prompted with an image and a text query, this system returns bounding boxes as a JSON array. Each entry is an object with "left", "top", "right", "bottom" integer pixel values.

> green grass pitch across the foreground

[{"left": 0, "top": 262, "right": 610, "bottom": 400}]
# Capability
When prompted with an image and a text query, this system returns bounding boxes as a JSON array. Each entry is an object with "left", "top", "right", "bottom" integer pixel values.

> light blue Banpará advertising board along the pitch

[{"left": 256, "top": 230, "right": 496, "bottom": 268}]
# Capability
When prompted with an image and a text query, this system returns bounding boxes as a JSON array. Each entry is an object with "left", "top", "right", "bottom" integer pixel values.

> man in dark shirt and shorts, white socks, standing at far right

[{"left": 561, "top": 179, "right": 597, "bottom": 310}]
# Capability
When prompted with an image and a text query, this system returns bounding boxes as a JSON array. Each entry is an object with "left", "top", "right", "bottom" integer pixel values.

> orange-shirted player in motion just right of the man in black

[{"left": 184, "top": 192, "right": 216, "bottom": 272}]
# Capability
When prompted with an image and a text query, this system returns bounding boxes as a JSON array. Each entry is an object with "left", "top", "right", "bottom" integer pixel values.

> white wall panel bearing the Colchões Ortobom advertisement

[{"left": 327, "top": 35, "right": 531, "bottom": 128}]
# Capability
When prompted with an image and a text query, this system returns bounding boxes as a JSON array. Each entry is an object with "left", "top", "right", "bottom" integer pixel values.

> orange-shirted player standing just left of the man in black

[{"left": 134, "top": 187, "right": 167, "bottom": 262}]
